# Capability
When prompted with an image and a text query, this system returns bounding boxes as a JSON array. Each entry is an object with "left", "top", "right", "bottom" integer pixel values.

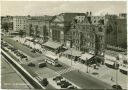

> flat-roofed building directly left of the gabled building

[{"left": 26, "top": 16, "right": 51, "bottom": 41}]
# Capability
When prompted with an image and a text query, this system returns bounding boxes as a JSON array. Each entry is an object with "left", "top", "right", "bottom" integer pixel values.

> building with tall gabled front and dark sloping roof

[{"left": 50, "top": 13, "right": 85, "bottom": 44}]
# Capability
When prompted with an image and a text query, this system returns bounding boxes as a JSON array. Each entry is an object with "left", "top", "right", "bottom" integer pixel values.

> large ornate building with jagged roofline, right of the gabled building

[{"left": 66, "top": 13, "right": 106, "bottom": 56}]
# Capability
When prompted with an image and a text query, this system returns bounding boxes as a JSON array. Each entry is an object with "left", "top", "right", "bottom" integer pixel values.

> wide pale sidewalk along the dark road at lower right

[{"left": 59, "top": 56, "right": 127, "bottom": 89}]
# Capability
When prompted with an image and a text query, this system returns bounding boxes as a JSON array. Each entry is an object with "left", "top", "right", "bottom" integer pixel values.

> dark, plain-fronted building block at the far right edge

[{"left": 105, "top": 14, "right": 127, "bottom": 49}]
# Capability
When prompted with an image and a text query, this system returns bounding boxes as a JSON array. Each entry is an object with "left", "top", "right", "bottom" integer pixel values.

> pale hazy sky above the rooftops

[{"left": 1, "top": 1, "right": 126, "bottom": 16}]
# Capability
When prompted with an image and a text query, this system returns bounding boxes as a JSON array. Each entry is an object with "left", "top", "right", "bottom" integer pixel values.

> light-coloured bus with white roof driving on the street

[{"left": 45, "top": 53, "right": 58, "bottom": 66}]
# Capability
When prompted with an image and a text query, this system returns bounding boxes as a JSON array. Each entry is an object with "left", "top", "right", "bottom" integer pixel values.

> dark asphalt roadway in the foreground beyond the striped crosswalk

[{"left": 62, "top": 70, "right": 111, "bottom": 89}]
